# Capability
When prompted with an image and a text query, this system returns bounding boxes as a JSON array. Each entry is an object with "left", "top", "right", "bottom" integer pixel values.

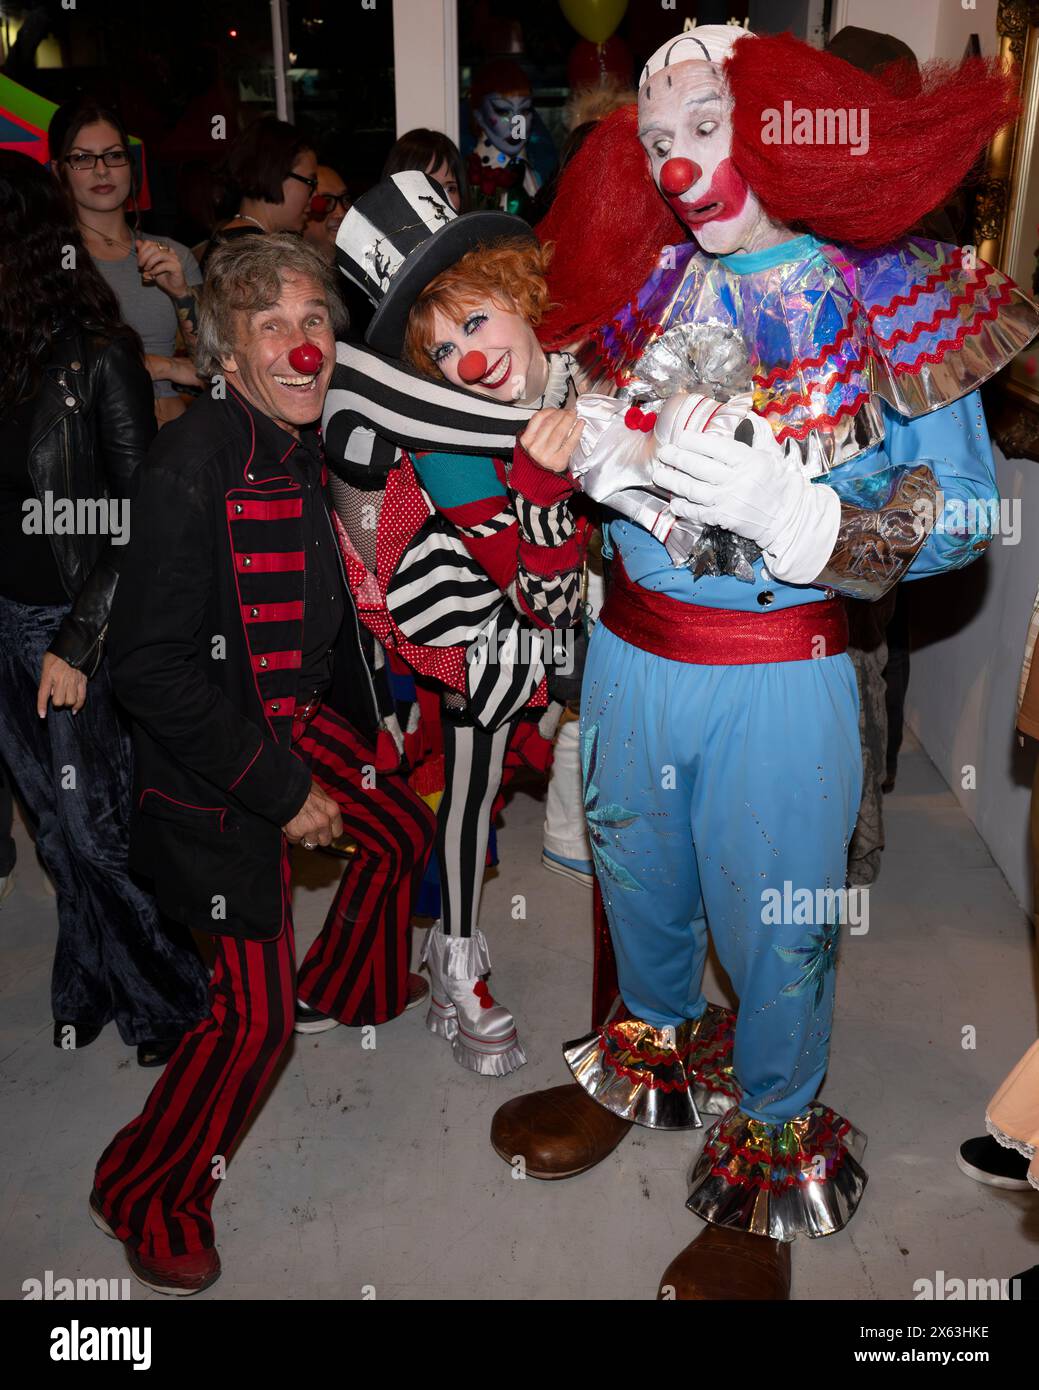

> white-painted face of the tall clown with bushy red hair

[{"left": 638, "top": 60, "right": 793, "bottom": 256}]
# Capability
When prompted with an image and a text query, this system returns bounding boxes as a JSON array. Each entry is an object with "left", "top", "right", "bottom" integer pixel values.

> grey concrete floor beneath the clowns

[{"left": 0, "top": 728, "right": 1039, "bottom": 1300}]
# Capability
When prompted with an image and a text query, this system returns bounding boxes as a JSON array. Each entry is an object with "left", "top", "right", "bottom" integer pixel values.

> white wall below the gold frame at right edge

[{"left": 905, "top": 450, "right": 1039, "bottom": 910}]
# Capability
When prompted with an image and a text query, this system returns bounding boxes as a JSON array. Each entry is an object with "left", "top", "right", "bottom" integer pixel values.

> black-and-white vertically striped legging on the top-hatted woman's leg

[{"left": 437, "top": 705, "right": 516, "bottom": 937}]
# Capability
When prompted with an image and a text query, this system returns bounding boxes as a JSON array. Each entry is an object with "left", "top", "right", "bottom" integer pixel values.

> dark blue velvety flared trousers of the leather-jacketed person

[{"left": 0, "top": 598, "right": 209, "bottom": 1044}]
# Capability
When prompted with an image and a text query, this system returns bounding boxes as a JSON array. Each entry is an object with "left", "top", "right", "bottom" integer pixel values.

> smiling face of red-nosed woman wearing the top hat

[{"left": 426, "top": 299, "right": 548, "bottom": 404}]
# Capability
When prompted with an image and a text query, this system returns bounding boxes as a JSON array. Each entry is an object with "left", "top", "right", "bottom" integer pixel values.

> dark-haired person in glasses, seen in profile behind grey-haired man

[{"left": 202, "top": 115, "right": 317, "bottom": 272}]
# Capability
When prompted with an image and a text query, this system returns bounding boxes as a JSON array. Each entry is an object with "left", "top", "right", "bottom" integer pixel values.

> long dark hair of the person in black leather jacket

[{"left": 0, "top": 150, "right": 140, "bottom": 416}]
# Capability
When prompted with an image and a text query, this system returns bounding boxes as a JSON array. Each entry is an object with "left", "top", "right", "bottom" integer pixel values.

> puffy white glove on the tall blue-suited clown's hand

[{"left": 652, "top": 416, "right": 840, "bottom": 584}]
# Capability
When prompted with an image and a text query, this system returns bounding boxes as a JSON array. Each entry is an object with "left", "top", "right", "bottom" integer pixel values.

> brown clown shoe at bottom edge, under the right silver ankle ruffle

[{"left": 657, "top": 1226, "right": 790, "bottom": 1302}]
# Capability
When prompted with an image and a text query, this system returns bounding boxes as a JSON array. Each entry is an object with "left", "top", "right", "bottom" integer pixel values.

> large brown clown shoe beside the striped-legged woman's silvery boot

[{"left": 491, "top": 1081, "right": 631, "bottom": 1179}]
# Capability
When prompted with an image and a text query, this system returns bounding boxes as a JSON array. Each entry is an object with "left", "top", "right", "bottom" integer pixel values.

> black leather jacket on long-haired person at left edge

[{"left": 29, "top": 327, "right": 156, "bottom": 677}]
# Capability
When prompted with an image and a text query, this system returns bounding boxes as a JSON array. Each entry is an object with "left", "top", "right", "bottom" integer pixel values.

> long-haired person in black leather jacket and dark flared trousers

[{"left": 0, "top": 150, "right": 207, "bottom": 1066}]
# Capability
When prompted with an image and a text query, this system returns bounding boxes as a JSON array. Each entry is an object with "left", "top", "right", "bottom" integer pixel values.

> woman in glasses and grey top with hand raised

[{"left": 47, "top": 101, "right": 202, "bottom": 425}]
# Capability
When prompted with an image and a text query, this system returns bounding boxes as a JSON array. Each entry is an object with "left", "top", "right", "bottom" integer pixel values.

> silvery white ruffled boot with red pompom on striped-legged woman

[{"left": 423, "top": 923, "right": 527, "bottom": 1076}]
